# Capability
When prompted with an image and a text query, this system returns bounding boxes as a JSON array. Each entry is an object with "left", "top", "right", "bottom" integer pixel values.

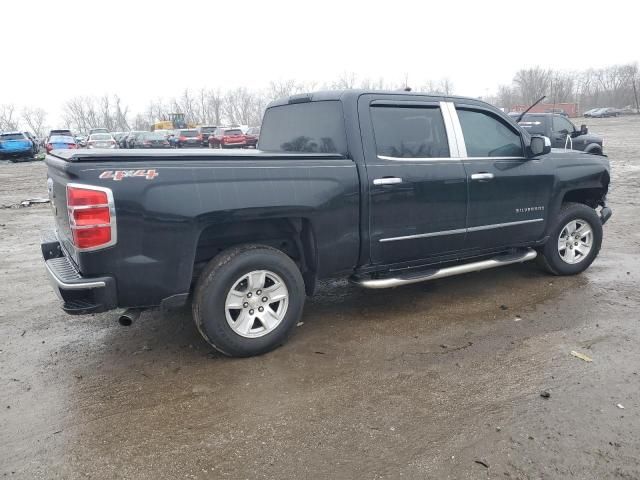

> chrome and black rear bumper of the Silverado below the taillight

[{"left": 40, "top": 232, "right": 117, "bottom": 315}]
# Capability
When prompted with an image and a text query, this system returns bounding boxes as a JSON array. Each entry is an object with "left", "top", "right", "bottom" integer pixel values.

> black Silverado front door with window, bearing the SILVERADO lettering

[{"left": 453, "top": 103, "right": 553, "bottom": 250}]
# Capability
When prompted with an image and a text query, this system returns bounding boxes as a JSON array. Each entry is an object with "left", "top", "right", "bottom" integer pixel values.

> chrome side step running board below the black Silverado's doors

[{"left": 352, "top": 249, "right": 538, "bottom": 288}]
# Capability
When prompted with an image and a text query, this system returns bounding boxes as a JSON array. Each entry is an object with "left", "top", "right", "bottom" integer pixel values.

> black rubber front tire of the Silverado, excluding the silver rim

[{"left": 538, "top": 203, "right": 602, "bottom": 275}]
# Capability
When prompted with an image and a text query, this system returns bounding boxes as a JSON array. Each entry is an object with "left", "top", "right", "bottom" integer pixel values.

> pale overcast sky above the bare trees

[{"left": 0, "top": 0, "right": 640, "bottom": 123}]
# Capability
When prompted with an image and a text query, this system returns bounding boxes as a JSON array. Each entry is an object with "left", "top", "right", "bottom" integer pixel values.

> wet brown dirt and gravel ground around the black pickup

[{"left": 0, "top": 117, "right": 640, "bottom": 479}]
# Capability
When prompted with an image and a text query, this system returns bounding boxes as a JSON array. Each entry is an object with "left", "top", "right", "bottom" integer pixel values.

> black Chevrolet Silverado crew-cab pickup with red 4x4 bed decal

[{"left": 42, "top": 90, "right": 611, "bottom": 356}]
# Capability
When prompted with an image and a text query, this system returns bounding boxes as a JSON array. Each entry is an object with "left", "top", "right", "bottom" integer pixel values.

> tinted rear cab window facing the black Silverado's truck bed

[{"left": 258, "top": 101, "right": 347, "bottom": 154}]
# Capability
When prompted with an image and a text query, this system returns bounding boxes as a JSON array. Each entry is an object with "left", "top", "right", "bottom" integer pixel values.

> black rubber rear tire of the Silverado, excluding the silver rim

[{"left": 192, "top": 245, "right": 306, "bottom": 357}]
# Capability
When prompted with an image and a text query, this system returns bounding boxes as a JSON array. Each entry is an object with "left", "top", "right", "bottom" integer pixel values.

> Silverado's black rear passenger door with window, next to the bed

[{"left": 358, "top": 95, "right": 467, "bottom": 265}]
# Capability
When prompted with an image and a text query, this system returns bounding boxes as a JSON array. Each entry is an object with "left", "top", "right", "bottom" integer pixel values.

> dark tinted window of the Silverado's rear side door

[{"left": 371, "top": 106, "right": 450, "bottom": 158}]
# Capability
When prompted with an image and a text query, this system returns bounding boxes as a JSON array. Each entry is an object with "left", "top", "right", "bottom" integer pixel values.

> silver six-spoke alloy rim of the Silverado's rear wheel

[{"left": 224, "top": 270, "right": 289, "bottom": 338}]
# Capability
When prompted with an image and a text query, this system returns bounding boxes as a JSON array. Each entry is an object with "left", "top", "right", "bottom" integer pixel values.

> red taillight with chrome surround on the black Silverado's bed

[{"left": 67, "top": 184, "right": 116, "bottom": 251}]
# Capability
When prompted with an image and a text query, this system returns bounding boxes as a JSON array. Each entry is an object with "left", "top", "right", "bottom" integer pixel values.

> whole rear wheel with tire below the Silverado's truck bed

[{"left": 193, "top": 245, "right": 305, "bottom": 357}]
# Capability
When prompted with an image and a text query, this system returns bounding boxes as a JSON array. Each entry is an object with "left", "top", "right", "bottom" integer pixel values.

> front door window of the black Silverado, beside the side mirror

[{"left": 457, "top": 108, "right": 524, "bottom": 157}]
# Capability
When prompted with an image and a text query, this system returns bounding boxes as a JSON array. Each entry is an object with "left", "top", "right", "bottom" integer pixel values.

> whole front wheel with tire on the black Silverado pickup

[{"left": 538, "top": 203, "right": 602, "bottom": 275}]
